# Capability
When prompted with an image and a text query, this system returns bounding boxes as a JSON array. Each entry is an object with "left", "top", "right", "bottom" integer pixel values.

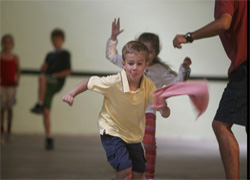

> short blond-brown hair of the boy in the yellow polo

[{"left": 122, "top": 41, "right": 149, "bottom": 62}]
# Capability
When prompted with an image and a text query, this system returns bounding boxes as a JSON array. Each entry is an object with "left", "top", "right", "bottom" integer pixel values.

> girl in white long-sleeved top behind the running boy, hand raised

[{"left": 106, "top": 19, "right": 191, "bottom": 179}]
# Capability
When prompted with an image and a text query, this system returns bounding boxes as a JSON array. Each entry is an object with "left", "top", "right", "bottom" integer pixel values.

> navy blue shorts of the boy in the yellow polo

[{"left": 101, "top": 133, "right": 146, "bottom": 173}]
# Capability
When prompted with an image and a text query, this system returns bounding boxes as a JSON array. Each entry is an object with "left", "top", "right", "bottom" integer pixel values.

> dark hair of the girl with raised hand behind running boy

[{"left": 137, "top": 32, "right": 177, "bottom": 76}]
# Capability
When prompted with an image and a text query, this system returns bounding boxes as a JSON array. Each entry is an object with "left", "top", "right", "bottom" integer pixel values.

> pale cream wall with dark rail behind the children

[{"left": 1, "top": 0, "right": 246, "bottom": 141}]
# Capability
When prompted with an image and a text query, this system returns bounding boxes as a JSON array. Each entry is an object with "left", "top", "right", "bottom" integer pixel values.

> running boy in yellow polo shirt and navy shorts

[{"left": 63, "top": 41, "right": 170, "bottom": 179}]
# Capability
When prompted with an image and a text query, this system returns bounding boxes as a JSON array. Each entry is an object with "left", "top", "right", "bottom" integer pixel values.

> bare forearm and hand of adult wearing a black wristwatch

[{"left": 173, "top": 13, "right": 232, "bottom": 48}]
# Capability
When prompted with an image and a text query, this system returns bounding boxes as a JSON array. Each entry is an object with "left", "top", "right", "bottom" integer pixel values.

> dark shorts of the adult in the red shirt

[{"left": 214, "top": 61, "right": 247, "bottom": 126}]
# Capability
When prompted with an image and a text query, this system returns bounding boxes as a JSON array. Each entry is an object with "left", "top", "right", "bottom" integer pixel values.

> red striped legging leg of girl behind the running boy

[{"left": 143, "top": 113, "right": 156, "bottom": 179}]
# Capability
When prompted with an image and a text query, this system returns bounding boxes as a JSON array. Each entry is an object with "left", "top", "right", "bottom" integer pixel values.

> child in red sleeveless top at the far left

[{"left": 0, "top": 34, "right": 20, "bottom": 144}]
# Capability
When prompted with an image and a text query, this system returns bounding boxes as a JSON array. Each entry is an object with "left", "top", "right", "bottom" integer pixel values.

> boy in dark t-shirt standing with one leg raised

[{"left": 31, "top": 29, "right": 71, "bottom": 150}]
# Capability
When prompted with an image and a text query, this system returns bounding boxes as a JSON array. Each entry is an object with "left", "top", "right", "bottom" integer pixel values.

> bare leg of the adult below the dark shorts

[{"left": 213, "top": 120, "right": 239, "bottom": 179}]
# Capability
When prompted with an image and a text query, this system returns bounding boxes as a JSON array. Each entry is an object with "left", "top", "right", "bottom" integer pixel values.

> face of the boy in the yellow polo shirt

[{"left": 122, "top": 53, "right": 148, "bottom": 83}]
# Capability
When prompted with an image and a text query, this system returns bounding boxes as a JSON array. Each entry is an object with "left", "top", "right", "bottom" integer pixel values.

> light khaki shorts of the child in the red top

[{"left": 0, "top": 86, "right": 16, "bottom": 109}]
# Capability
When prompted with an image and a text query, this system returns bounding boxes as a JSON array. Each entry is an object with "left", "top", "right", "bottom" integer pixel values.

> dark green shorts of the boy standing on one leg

[{"left": 43, "top": 75, "right": 63, "bottom": 109}]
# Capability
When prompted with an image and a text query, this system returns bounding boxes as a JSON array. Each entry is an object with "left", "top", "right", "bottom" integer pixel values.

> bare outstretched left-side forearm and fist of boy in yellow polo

[{"left": 63, "top": 80, "right": 89, "bottom": 106}]
